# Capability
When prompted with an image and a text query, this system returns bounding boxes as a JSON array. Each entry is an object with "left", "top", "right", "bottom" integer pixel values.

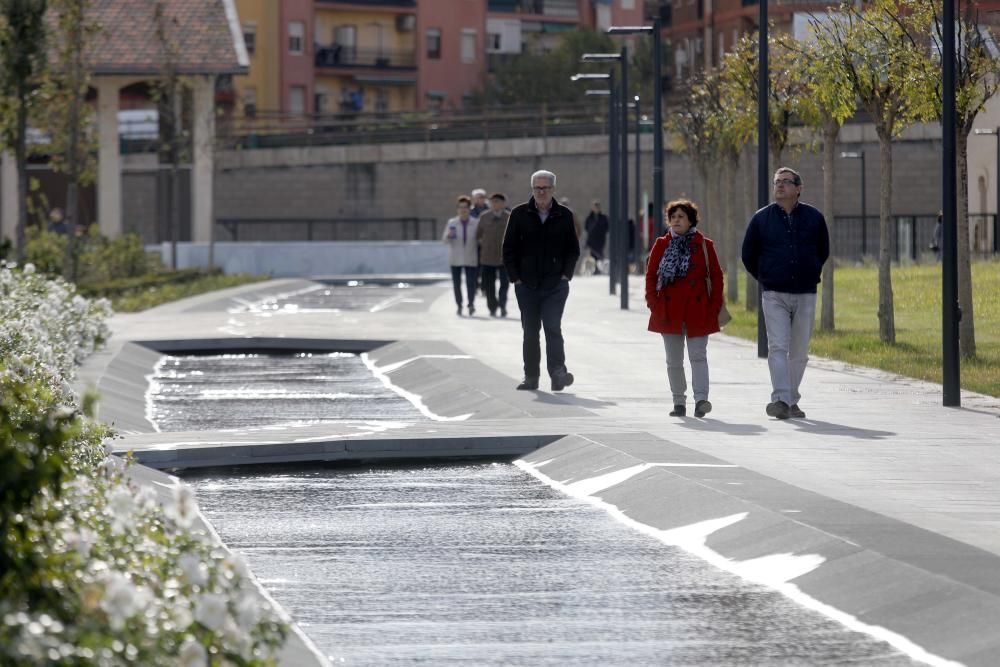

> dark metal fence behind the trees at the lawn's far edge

[{"left": 830, "top": 213, "right": 1000, "bottom": 262}]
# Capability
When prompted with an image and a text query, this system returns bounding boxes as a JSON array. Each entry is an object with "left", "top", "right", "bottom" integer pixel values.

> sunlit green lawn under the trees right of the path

[{"left": 726, "top": 262, "right": 1000, "bottom": 397}]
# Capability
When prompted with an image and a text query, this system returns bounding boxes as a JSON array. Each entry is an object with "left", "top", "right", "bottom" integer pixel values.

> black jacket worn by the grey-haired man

[{"left": 503, "top": 197, "right": 580, "bottom": 289}]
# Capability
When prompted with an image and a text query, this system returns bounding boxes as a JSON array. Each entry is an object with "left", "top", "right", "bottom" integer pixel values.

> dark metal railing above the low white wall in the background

[{"left": 215, "top": 218, "right": 439, "bottom": 241}]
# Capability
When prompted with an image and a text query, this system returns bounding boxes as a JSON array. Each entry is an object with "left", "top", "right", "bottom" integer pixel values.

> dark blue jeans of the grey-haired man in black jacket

[{"left": 514, "top": 279, "right": 569, "bottom": 377}]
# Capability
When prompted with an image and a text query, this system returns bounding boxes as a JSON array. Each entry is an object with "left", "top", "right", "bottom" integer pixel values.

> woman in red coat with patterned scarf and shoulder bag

[{"left": 646, "top": 199, "right": 723, "bottom": 417}]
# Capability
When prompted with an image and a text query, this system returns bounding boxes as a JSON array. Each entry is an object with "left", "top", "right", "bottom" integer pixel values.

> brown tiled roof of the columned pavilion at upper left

[{"left": 87, "top": 0, "right": 246, "bottom": 75}]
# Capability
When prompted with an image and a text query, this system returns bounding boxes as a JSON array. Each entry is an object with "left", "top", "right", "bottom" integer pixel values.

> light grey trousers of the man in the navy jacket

[{"left": 761, "top": 291, "right": 816, "bottom": 405}]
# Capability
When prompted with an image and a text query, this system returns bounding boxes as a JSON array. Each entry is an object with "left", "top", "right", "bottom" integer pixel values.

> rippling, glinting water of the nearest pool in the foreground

[{"left": 189, "top": 464, "right": 912, "bottom": 665}]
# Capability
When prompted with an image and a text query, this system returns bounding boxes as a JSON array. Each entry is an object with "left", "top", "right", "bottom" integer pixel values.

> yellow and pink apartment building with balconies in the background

[{"left": 234, "top": 0, "right": 643, "bottom": 115}]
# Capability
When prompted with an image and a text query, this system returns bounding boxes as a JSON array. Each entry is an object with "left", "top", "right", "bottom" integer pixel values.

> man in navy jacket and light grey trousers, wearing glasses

[{"left": 743, "top": 167, "right": 830, "bottom": 419}]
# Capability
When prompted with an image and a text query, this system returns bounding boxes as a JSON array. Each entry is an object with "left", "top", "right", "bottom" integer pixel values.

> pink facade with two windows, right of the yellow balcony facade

[{"left": 417, "top": 0, "right": 486, "bottom": 109}]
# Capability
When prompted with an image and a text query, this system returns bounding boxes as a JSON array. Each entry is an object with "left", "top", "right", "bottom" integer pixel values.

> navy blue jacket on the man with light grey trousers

[{"left": 743, "top": 202, "right": 830, "bottom": 294}]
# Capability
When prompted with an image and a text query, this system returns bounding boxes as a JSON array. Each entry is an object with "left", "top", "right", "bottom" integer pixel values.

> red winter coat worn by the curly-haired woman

[{"left": 646, "top": 231, "right": 724, "bottom": 338}]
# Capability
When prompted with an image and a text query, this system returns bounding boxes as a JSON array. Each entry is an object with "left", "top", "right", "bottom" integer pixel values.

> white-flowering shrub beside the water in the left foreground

[{"left": 0, "top": 265, "right": 286, "bottom": 667}]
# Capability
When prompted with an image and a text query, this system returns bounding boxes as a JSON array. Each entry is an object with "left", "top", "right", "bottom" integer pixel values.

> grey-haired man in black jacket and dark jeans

[{"left": 503, "top": 171, "right": 580, "bottom": 391}]
